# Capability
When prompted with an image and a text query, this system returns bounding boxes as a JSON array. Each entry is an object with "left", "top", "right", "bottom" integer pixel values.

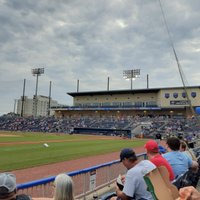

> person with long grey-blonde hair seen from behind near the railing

[{"left": 33, "top": 174, "right": 74, "bottom": 200}]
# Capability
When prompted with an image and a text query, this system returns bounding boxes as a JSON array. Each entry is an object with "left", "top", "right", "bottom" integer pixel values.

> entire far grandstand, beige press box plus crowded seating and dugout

[{"left": 0, "top": 86, "right": 200, "bottom": 138}]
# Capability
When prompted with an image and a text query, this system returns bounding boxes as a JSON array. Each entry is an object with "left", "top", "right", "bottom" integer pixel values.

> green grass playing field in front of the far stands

[{"left": 0, "top": 132, "right": 145, "bottom": 171}]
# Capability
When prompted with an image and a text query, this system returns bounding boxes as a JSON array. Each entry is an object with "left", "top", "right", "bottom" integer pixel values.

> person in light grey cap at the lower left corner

[{"left": 0, "top": 173, "right": 31, "bottom": 200}]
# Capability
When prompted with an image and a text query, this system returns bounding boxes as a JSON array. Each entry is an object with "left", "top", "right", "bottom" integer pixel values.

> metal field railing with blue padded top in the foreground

[{"left": 17, "top": 153, "right": 146, "bottom": 199}]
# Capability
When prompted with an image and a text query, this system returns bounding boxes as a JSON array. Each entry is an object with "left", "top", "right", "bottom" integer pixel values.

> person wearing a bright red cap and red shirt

[{"left": 144, "top": 140, "right": 175, "bottom": 181}]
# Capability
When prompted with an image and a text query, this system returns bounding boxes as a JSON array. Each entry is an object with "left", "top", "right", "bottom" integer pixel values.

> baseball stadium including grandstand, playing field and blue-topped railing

[{"left": 0, "top": 83, "right": 200, "bottom": 199}]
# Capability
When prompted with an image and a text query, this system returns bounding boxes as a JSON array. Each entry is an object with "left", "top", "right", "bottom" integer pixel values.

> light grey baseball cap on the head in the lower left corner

[{"left": 0, "top": 173, "right": 17, "bottom": 195}]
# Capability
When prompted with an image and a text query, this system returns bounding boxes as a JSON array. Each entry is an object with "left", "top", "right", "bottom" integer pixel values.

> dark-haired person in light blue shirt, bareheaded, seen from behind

[{"left": 162, "top": 137, "right": 198, "bottom": 178}]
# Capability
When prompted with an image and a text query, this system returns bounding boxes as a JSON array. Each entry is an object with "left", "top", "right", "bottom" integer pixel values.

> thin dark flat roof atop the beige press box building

[{"left": 67, "top": 86, "right": 200, "bottom": 97}]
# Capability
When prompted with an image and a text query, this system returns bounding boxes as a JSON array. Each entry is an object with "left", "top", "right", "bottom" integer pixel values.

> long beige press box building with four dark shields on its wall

[{"left": 53, "top": 86, "right": 200, "bottom": 117}]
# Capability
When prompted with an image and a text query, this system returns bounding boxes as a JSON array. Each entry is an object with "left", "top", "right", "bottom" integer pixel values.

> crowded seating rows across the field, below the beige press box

[{"left": 0, "top": 115, "right": 200, "bottom": 140}]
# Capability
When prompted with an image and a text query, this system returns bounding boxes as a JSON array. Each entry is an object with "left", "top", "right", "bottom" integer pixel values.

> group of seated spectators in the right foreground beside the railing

[{"left": 103, "top": 136, "right": 200, "bottom": 200}]
